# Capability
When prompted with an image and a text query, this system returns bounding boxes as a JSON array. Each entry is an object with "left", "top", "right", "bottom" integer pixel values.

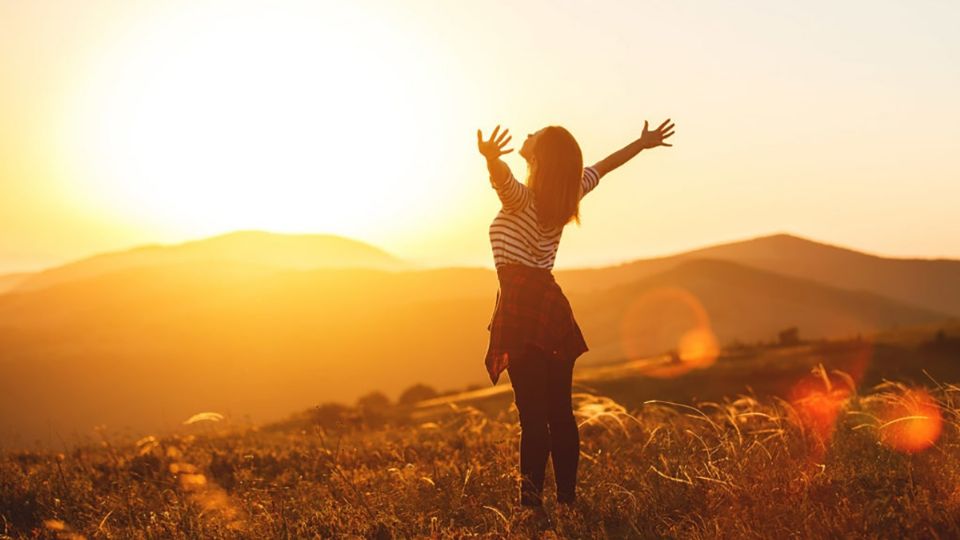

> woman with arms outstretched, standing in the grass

[{"left": 477, "top": 119, "right": 674, "bottom": 509}]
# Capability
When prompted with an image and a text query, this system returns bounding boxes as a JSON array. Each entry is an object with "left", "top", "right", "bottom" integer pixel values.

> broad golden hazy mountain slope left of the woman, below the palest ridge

[{"left": 0, "top": 263, "right": 496, "bottom": 445}]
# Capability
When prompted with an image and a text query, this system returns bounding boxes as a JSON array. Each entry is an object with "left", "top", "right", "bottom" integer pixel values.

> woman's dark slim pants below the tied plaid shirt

[{"left": 507, "top": 345, "right": 580, "bottom": 506}]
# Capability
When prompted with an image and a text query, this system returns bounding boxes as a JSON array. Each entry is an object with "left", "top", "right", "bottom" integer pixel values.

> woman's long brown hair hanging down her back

[{"left": 527, "top": 126, "right": 583, "bottom": 229}]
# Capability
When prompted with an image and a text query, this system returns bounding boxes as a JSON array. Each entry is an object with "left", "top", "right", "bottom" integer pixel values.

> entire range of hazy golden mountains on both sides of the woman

[{"left": 0, "top": 232, "right": 960, "bottom": 445}]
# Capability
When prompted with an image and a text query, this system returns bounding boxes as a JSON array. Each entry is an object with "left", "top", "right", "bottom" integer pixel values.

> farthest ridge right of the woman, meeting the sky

[{"left": 555, "top": 234, "right": 960, "bottom": 316}]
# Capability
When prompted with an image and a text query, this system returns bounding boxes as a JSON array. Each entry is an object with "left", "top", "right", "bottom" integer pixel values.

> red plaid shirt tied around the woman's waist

[{"left": 484, "top": 264, "right": 589, "bottom": 384}]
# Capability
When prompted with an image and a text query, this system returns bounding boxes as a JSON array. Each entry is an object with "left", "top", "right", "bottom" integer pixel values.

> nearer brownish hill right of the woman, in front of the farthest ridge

[{"left": 569, "top": 259, "right": 950, "bottom": 359}]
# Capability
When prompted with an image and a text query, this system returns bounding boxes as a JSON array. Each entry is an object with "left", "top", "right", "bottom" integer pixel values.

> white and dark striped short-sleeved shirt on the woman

[{"left": 490, "top": 162, "right": 600, "bottom": 269}]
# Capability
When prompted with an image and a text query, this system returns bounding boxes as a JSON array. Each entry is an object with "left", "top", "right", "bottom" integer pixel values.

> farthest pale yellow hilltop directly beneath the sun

[{"left": 10, "top": 231, "right": 411, "bottom": 292}]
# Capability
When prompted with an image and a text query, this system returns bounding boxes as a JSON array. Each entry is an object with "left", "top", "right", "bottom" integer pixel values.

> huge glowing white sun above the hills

[{"left": 59, "top": 2, "right": 462, "bottom": 237}]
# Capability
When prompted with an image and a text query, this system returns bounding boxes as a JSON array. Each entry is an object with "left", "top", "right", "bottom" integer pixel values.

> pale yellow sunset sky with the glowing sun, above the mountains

[{"left": 0, "top": 0, "right": 960, "bottom": 273}]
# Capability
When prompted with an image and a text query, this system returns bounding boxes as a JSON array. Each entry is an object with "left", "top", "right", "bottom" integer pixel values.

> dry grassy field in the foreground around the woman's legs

[{"left": 0, "top": 332, "right": 960, "bottom": 538}]
